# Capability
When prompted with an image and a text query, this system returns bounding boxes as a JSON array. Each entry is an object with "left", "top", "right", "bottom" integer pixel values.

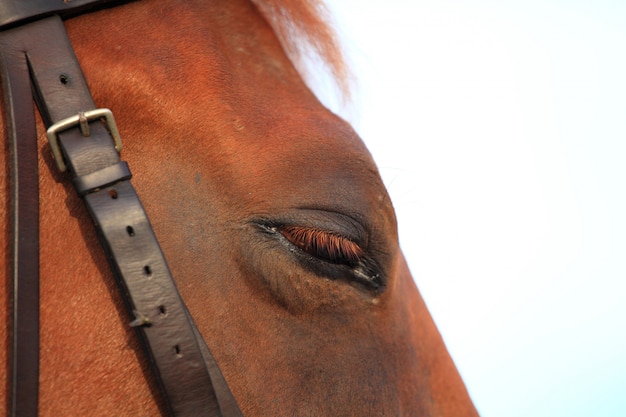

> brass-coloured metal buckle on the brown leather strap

[{"left": 46, "top": 109, "right": 122, "bottom": 172}]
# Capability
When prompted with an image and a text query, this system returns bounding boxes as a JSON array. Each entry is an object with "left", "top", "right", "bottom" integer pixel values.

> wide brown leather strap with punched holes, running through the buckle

[{"left": 0, "top": 16, "right": 241, "bottom": 417}]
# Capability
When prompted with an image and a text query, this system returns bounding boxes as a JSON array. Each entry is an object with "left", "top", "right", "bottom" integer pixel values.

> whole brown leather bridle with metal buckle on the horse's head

[{"left": 0, "top": 0, "right": 241, "bottom": 417}]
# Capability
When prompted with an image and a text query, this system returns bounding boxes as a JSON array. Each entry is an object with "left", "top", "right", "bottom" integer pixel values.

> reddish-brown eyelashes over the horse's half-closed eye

[{"left": 280, "top": 226, "right": 363, "bottom": 264}]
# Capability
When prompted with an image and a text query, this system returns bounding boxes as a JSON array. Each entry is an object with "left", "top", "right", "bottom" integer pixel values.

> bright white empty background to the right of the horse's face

[{"left": 314, "top": 0, "right": 626, "bottom": 417}]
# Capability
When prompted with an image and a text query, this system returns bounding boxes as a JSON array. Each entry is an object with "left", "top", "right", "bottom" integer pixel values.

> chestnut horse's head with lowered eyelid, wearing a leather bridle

[{"left": 0, "top": 0, "right": 477, "bottom": 416}]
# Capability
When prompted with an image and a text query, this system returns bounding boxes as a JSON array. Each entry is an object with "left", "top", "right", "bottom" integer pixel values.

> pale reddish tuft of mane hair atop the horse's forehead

[{"left": 251, "top": 0, "right": 350, "bottom": 101}]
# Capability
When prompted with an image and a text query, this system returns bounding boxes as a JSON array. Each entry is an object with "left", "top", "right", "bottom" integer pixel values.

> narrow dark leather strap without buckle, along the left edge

[{"left": 0, "top": 24, "right": 39, "bottom": 416}]
